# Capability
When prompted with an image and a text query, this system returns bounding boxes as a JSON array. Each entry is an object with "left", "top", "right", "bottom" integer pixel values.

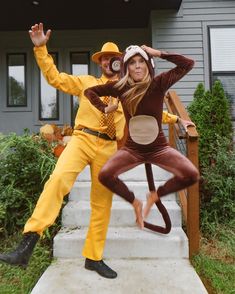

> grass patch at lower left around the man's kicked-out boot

[{"left": 0, "top": 233, "right": 52, "bottom": 294}]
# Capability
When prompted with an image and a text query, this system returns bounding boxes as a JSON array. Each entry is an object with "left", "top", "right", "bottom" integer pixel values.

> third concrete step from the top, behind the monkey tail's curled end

[{"left": 62, "top": 200, "right": 182, "bottom": 228}]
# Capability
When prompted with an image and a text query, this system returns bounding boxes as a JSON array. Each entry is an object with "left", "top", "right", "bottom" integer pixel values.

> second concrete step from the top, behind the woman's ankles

[{"left": 69, "top": 181, "right": 176, "bottom": 201}]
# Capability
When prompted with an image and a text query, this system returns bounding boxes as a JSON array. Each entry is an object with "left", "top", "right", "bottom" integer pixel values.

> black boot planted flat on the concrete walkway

[{"left": 85, "top": 258, "right": 117, "bottom": 279}]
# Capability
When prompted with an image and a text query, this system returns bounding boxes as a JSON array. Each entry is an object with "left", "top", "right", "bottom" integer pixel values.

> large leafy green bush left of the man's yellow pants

[{"left": 0, "top": 131, "right": 56, "bottom": 234}]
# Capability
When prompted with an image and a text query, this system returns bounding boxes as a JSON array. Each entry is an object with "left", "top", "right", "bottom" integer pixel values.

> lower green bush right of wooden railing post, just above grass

[{"left": 198, "top": 140, "right": 235, "bottom": 231}]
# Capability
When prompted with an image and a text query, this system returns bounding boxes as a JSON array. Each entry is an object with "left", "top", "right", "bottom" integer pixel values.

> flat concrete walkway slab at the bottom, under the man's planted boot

[{"left": 31, "top": 258, "right": 207, "bottom": 294}]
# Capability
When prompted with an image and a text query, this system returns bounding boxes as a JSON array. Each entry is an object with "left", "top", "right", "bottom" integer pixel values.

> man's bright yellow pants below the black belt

[{"left": 24, "top": 131, "right": 117, "bottom": 260}]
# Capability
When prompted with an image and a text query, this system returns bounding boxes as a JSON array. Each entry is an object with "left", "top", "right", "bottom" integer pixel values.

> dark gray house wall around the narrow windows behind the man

[{"left": 0, "top": 28, "right": 151, "bottom": 134}]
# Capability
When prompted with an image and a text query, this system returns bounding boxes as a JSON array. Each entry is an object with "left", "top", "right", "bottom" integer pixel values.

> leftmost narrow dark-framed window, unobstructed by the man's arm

[{"left": 7, "top": 54, "right": 27, "bottom": 107}]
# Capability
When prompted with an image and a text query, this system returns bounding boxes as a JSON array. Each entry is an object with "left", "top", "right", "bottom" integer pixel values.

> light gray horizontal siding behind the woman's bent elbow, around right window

[{"left": 151, "top": 0, "right": 235, "bottom": 106}]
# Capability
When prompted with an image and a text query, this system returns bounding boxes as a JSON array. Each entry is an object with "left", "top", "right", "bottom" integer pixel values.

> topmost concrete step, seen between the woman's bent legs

[{"left": 77, "top": 164, "right": 172, "bottom": 182}]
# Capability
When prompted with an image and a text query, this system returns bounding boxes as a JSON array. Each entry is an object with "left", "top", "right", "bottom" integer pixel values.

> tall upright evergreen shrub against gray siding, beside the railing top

[{"left": 188, "top": 81, "right": 233, "bottom": 167}]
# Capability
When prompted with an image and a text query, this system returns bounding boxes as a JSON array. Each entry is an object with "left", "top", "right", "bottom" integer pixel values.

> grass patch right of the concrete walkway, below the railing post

[{"left": 193, "top": 225, "right": 235, "bottom": 294}]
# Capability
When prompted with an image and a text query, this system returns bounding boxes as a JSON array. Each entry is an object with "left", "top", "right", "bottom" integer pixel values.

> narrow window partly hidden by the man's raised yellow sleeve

[{"left": 39, "top": 53, "right": 59, "bottom": 120}]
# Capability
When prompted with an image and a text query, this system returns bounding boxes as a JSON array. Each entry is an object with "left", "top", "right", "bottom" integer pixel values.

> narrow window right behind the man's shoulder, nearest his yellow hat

[{"left": 70, "top": 52, "right": 89, "bottom": 126}]
